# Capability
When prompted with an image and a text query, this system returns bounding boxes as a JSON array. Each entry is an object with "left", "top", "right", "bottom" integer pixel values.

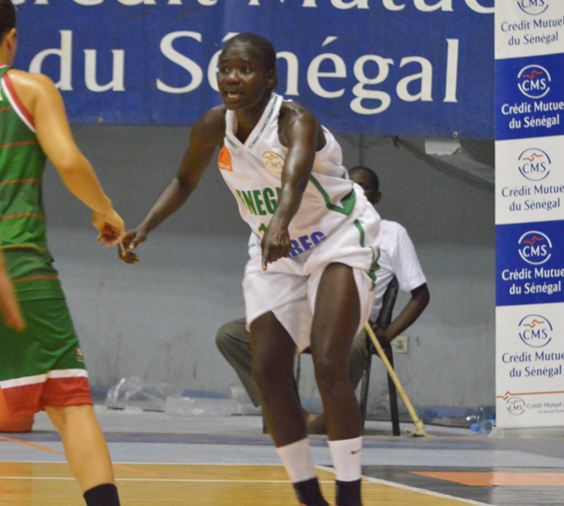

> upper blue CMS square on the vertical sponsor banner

[{"left": 495, "top": 54, "right": 564, "bottom": 140}]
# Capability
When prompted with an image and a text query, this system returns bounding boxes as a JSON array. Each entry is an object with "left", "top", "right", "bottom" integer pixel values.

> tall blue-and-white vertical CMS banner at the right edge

[{"left": 495, "top": 0, "right": 564, "bottom": 428}]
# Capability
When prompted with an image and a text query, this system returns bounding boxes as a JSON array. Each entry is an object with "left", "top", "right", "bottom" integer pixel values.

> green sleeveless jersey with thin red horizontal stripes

[{"left": 0, "top": 65, "right": 63, "bottom": 300}]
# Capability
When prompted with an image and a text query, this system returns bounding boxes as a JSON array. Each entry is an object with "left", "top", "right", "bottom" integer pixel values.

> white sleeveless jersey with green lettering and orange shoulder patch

[{"left": 218, "top": 93, "right": 369, "bottom": 257}]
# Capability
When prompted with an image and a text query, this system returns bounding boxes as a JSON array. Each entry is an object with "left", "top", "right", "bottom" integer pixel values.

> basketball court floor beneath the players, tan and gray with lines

[{"left": 0, "top": 407, "right": 564, "bottom": 506}]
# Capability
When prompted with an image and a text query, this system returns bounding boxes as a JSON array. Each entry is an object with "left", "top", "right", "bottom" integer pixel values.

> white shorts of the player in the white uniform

[{"left": 243, "top": 206, "right": 380, "bottom": 352}]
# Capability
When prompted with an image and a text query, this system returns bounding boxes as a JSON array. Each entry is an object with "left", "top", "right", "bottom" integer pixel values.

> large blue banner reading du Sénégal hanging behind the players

[{"left": 15, "top": 0, "right": 494, "bottom": 139}]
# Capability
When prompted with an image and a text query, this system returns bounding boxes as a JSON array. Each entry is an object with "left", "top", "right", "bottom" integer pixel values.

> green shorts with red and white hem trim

[{"left": 0, "top": 299, "right": 92, "bottom": 417}]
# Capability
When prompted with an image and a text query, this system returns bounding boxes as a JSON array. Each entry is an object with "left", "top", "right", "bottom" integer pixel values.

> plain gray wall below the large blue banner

[{"left": 45, "top": 126, "right": 495, "bottom": 414}]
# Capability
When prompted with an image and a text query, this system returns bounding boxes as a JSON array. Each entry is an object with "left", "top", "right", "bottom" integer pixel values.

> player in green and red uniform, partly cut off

[{"left": 0, "top": 0, "right": 124, "bottom": 506}]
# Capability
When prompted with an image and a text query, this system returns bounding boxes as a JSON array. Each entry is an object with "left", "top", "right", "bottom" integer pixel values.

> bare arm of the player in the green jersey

[{"left": 10, "top": 70, "right": 124, "bottom": 246}]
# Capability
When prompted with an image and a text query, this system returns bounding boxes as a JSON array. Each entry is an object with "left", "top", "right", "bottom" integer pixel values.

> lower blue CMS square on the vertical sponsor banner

[{"left": 496, "top": 221, "right": 564, "bottom": 306}]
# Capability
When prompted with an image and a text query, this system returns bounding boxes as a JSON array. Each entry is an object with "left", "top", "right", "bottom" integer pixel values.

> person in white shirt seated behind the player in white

[{"left": 216, "top": 166, "right": 430, "bottom": 434}]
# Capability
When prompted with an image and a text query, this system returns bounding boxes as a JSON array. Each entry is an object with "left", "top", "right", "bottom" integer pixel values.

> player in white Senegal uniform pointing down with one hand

[{"left": 122, "top": 34, "right": 379, "bottom": 506}]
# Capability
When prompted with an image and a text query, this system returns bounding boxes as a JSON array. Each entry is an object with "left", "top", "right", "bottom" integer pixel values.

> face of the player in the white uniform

[{"left": 217, "top": 42, "right": 274, "bottom": 110}]
